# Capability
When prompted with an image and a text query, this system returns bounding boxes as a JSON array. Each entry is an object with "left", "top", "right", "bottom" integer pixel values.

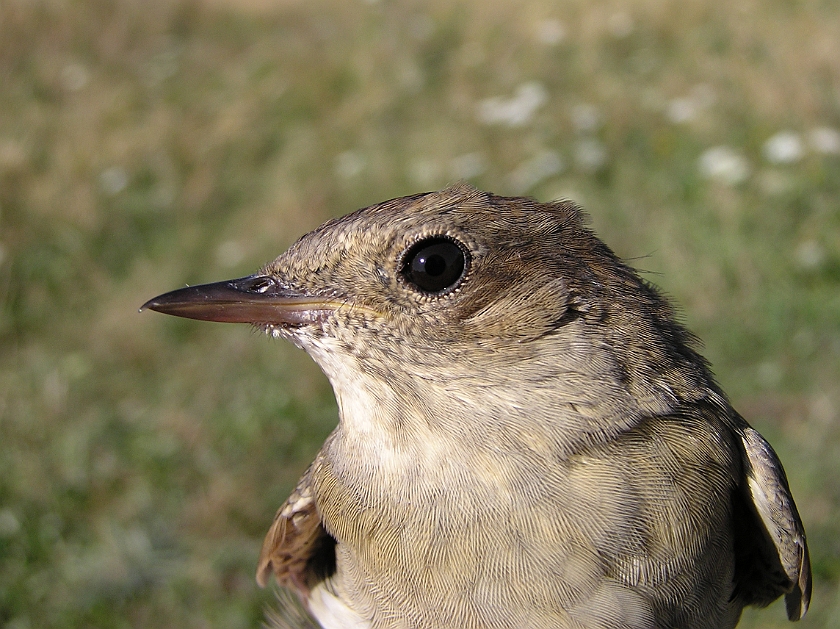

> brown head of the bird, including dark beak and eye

[{"left": 143, "top": 185, "right": 713, "bottom": 454}]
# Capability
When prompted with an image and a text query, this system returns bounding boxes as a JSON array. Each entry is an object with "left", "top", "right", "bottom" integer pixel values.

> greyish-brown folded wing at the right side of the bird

[{"left": 736, "top": 426, "right": 811, "bottom": 620}]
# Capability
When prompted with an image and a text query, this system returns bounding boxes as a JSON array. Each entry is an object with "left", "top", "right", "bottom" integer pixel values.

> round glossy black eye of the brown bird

[{"left": 402, "top": 238, "right": 467, "bottom": 293}]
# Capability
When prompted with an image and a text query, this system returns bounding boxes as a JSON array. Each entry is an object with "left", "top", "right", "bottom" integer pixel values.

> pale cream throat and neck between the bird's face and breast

[{"left": 298, "top": 321, "right": 720, "bottom": 502}]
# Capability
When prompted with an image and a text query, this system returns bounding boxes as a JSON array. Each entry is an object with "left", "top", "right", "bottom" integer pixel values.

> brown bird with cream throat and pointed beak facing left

[{"left": 143, "top": 183, "right": 811, "bottom": 629}]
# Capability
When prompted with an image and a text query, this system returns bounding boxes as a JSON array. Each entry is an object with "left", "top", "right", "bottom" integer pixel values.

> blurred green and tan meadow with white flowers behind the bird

[{"left": 0, "top": 0, "right": 840, "bottom": 629}]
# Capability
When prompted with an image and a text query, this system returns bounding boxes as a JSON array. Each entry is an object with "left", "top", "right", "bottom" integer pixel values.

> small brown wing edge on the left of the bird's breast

[{"left": 257, "top": 467, "right": 335, "bottom": 602}]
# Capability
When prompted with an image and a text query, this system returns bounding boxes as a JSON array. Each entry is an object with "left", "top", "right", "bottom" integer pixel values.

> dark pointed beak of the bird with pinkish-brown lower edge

[{"left": 140, "top": 275, "right": 334, "bottom": 326}]
